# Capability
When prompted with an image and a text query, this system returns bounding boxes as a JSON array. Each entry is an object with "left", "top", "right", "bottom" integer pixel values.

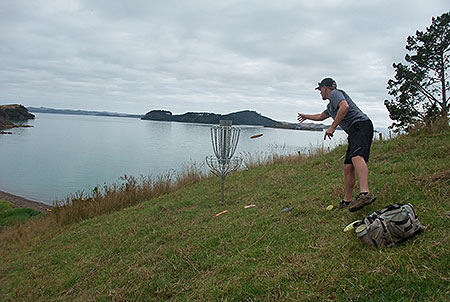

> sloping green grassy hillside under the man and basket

[{"left": 0, "top": 126, "right": 450, "bottom": 301}]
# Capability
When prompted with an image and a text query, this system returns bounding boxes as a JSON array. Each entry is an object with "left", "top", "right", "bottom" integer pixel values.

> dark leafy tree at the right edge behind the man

[{"left": 384, "top": 12, "right": 450, "bottom": 131}]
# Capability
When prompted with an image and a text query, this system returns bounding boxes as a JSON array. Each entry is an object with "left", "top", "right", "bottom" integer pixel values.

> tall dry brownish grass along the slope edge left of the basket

[{"left": 0, "top": 163, "right": 208, "bottom": 244}]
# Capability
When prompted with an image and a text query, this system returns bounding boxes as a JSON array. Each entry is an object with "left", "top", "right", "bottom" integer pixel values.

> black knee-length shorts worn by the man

[{"left": 344, "top": 120, "right": 373, "bottom": 164}]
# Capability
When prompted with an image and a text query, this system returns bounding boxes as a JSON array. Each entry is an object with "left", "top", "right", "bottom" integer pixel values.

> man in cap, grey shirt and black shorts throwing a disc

[{"left": 298, "top": 78, "right": 376, "bottom": 212}]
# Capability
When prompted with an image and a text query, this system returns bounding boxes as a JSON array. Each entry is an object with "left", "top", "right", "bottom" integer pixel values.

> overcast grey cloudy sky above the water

[{"left": 0, "top": 0, "right": 449, "bottom": 127}]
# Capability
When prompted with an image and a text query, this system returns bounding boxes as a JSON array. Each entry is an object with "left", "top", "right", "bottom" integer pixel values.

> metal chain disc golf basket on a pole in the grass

[{"left": 206, "top": 121, "right": 242, "bottom": 203}]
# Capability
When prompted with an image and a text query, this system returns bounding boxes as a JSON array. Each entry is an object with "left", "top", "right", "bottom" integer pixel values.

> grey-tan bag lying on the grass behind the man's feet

[{"left": 354, "top": 203, "right": 425, "bottom": 247}]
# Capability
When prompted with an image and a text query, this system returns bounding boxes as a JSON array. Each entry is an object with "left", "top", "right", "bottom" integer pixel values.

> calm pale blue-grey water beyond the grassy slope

[{"left": 0, "top": 113, "right": 346, "bottom": 204}]
